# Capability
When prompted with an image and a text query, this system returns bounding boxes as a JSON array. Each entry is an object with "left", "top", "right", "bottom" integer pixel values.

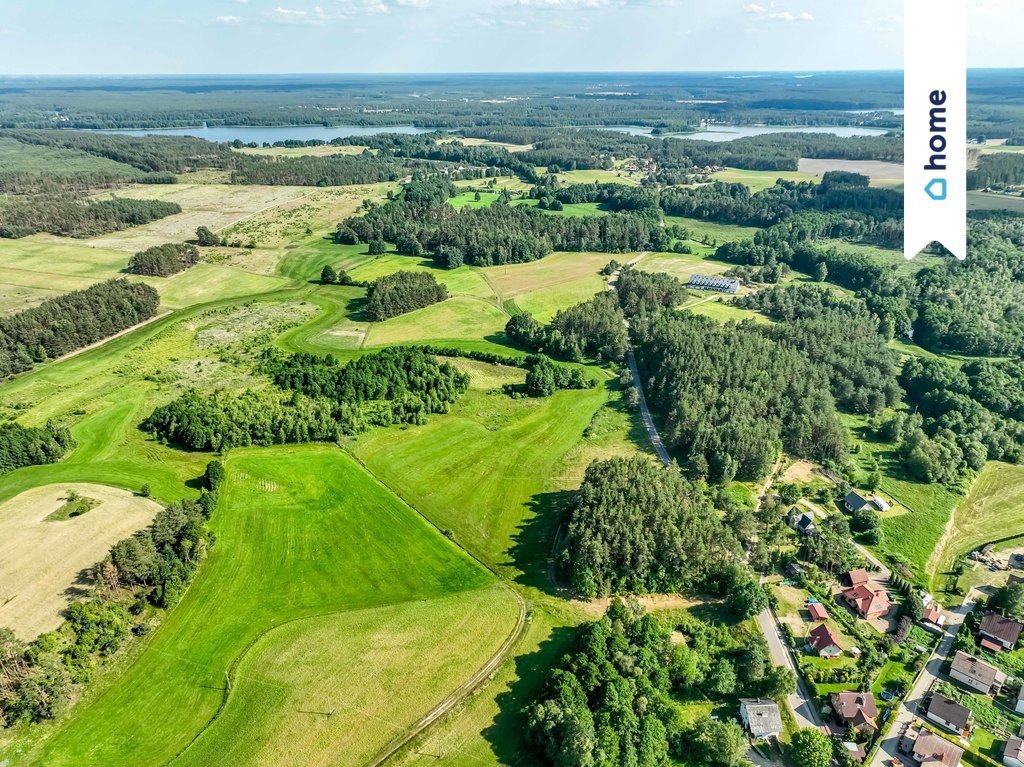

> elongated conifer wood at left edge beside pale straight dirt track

[{"left": 0, "top": 280, "right": 160, "bottom": 377}]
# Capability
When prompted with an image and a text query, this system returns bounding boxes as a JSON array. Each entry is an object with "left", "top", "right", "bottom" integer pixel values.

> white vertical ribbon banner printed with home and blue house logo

[{"left": 903, "top": 0, "right": 967, "bottom": 258}]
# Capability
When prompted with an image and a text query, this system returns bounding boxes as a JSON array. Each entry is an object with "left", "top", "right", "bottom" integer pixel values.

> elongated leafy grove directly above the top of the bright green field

[{"left": 141, "top": 346, "right": 469, "bottom": 451}]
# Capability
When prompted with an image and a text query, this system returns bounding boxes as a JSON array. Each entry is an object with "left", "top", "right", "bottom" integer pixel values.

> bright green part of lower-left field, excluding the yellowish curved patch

[{"left": 12, "top": 445, "right": 512, "bottom": 765}]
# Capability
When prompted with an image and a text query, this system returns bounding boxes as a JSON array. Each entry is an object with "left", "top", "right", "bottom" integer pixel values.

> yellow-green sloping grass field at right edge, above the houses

[{"left": 929, "top": 462, "right": 1024, "bottom": 585}]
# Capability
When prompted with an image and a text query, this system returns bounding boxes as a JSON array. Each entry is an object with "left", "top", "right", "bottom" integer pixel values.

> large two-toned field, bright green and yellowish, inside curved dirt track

[{"left": 11, "top": 445, "right": 517, "bottom": 765}]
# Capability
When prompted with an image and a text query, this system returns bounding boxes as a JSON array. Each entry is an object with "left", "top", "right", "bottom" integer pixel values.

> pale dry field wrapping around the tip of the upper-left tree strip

[{"left": 85, "top": 183, "right": 317, "bottom": 253}]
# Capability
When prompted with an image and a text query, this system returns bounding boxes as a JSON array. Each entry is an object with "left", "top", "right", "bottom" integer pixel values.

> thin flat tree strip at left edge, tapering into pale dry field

[{"left": 0, "top": 194, "right": 181, "bottom": 239}]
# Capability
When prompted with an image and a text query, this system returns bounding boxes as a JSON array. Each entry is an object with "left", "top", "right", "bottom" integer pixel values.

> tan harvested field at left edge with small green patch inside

[{"left": 0, "top": 483, "right": 160, "bottom": 640}]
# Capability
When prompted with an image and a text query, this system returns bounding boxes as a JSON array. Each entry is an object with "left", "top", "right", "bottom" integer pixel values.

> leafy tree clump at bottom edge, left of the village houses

[{"left": 526, "top": 599, "right": 796, "bottom": 767}]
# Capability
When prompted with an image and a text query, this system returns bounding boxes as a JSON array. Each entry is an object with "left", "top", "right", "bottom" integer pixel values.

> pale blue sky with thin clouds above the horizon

[{"left": 0, "top": 0, "right": 1024, "bottom": 75}]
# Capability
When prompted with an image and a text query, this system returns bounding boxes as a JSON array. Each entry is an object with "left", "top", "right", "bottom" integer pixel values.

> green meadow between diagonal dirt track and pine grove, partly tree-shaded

[{"left": 352, "top": 387, "right": 608, "bottom": 579}]
